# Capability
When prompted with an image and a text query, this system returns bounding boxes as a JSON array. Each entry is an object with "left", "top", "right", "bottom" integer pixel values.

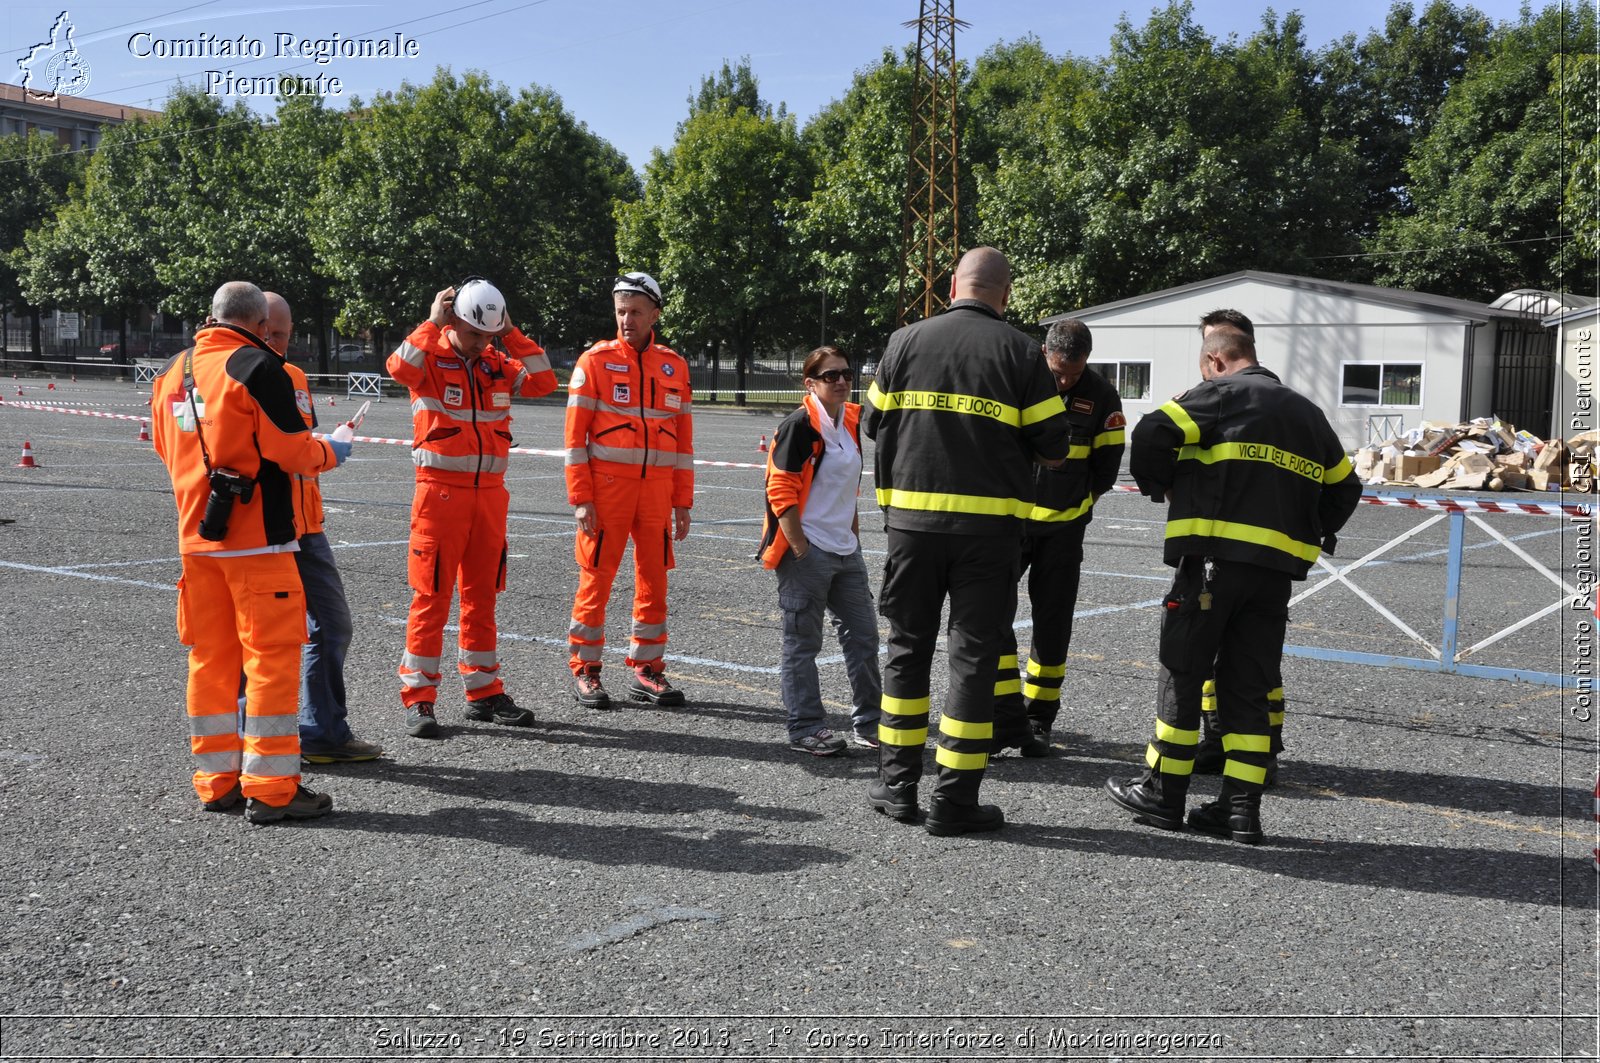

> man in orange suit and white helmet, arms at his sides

[{"left": 566, "top": 272, "right": 694, "bottom": 709}]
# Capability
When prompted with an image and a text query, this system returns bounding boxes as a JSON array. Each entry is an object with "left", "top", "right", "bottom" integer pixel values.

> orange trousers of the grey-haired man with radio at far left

[{"left": 178, "top": 554, "right": 306, "bottom": 805}]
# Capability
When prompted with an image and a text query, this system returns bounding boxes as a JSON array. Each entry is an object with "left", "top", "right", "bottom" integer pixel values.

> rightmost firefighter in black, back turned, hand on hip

[{"left": 1106, "top": 328, "right": 1362, "bottom": 844}]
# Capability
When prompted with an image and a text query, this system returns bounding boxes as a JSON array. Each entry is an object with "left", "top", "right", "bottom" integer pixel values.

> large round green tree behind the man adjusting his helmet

[{"left": 312, "top": 70, "right": 637, "bottom": 346}]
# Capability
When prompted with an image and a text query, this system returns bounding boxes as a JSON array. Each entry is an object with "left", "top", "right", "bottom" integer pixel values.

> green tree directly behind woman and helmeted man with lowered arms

[{"left": 618, "top": 65, "right": 813, "bottom": 403}]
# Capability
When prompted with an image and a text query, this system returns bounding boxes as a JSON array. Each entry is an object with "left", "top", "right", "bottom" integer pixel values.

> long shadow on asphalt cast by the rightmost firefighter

[{"left": 995, "top": 826, "right": 1595, "bottom": 909}]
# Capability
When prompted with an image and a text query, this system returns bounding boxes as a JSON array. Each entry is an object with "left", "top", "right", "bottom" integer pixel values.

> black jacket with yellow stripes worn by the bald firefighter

[{"left": 861, "top": 299, "right": 1067, "bottom": 535}]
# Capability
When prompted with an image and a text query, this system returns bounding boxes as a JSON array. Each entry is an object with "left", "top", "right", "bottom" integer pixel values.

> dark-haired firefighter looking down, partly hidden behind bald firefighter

[{"left": 995, "top": 319, "right": 1128, "bottom": 757}]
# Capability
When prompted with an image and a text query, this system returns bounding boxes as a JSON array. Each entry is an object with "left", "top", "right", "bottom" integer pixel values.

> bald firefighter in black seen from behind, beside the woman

[{"left": 862, "top": 248, "right": 1067, "bottom": 834}]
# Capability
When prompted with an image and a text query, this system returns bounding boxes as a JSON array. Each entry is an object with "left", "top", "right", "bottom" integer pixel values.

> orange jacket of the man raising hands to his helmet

[{"left": 384, "top": 322, "right": 555, "bottom": 487}]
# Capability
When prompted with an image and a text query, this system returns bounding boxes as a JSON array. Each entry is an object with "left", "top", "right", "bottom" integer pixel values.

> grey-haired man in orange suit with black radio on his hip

[{"left": 150, "top": 280, "right": 350, "bottom": 823}]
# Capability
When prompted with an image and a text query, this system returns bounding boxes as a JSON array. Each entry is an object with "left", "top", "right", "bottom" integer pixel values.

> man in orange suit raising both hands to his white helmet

[{"left": 386, "top": 277, "right": 555, "bottom": 738}]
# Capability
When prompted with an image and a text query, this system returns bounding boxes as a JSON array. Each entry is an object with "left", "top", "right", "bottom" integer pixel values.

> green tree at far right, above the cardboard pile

[{"left": 1371, "top": 5, "right": 1595, "bottom": 299}]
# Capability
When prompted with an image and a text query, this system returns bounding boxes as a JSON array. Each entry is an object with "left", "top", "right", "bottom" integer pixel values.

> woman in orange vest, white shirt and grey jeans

[{"left": 762, "top": 347, "right": 883, "bottom": 757}]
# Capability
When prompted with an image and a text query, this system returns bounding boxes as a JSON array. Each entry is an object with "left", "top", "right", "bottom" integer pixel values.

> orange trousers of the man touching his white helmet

[{"left": 400, "top": 480, "right": 510, "bottom": 706}]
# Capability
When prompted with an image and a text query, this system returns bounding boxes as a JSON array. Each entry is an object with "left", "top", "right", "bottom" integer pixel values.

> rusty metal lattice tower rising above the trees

[{"left": 896, "top": 0, "right": 966, "bottom": 325}]
